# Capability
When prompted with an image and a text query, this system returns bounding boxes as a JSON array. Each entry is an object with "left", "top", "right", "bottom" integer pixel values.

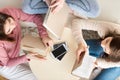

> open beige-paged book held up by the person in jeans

[{"left": 43, "top": 4, "right": 70, "bottom": 39}]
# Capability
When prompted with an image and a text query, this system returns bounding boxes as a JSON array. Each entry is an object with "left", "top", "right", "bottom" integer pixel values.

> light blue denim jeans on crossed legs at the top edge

[{"left": 22, "top": 0, "right": 100, "bottom": 18}]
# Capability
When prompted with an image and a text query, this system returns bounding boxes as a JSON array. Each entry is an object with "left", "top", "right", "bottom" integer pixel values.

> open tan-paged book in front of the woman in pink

[{"left": 21, "top": 34, "right": 48, "bottom": 56}]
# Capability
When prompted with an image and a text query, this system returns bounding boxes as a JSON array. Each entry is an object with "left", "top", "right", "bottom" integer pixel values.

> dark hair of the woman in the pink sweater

[{"left": 0, "top": 12, "right": 14, "bottom": 41}]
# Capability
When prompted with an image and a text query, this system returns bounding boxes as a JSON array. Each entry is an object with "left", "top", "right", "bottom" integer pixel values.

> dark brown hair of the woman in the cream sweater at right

[{"left": 103, "top": 32, "right": 120, "bottom": 62}]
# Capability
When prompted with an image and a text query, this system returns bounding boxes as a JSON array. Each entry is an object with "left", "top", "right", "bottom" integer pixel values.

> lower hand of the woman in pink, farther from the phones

[{"left": 26, "top": 52, "right": 46, "bottom": 60}]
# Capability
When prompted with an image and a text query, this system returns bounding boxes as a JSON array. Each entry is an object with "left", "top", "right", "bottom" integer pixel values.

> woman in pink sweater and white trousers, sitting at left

[{"left": 0, "top": 8, "right": 52, "bottom": 80}]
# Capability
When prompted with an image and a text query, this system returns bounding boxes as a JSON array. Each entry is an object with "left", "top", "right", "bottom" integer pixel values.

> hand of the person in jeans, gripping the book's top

[{"left": 50, "top": 0, "right": 65, "bottom": 13}]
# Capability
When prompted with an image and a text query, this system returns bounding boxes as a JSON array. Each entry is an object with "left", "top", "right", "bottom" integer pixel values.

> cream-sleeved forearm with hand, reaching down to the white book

[{"left": 71, "top": 19, "right": 87, "bottom": 63}]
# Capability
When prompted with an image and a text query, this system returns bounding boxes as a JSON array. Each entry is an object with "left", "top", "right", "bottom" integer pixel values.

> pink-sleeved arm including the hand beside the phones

[{"left": 9, "top": 9, "right": 53, "bottom": 47}]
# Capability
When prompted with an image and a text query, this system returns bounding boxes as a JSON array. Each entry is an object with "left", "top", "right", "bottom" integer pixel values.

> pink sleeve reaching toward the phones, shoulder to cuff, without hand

[{"left": 6, "top": 8, "right": 48, "bottom": 38}]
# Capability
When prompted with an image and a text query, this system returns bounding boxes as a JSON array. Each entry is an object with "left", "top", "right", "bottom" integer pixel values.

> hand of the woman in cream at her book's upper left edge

[{"left": 76, "top": 43, "right": 88, "bottom": 63}]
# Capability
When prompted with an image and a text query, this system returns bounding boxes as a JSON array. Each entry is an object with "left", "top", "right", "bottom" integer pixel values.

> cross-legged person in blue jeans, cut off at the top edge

[{"left": 22, "top": 0, "right": 100, "bottom": 18}]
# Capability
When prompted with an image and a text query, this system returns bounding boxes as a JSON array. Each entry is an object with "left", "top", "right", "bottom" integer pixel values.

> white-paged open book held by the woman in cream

[{"left": 72, "top": 53, "right": 96, "bottom": 79}]
